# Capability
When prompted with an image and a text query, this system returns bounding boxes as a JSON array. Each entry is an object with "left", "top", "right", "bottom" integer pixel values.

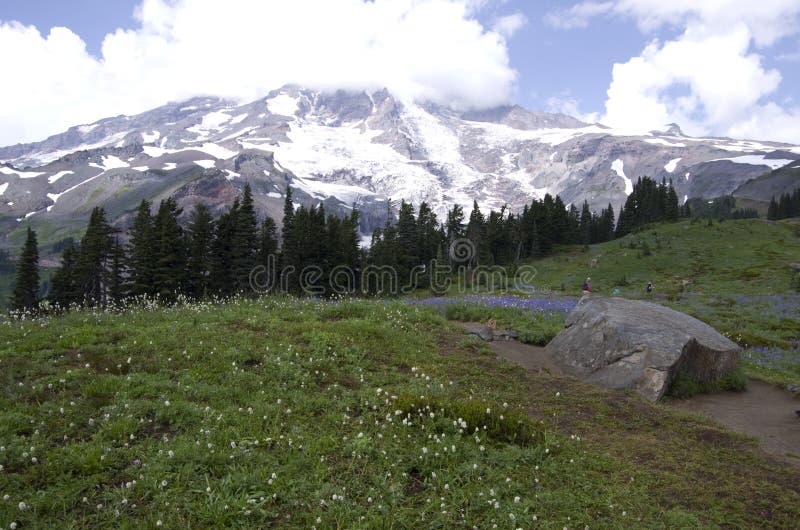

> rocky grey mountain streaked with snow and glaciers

[{"left": 0, "top": 86, "right": 800, "bottom": 245}]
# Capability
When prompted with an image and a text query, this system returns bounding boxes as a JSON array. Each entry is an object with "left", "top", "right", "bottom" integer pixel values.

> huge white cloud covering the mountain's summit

[{"left": 0, "top": 0, "right": 519, "bottom": 145}]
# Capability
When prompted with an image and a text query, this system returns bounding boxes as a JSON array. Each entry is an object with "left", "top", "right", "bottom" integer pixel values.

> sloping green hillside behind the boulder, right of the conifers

[{"left": 533, "top": 219, "right": 800, "bottom": 297}]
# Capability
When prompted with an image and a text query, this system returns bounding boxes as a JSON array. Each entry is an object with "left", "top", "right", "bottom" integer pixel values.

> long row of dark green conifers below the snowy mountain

[{"left": 6, "top": 177, "right": 678, "bottom": 310}]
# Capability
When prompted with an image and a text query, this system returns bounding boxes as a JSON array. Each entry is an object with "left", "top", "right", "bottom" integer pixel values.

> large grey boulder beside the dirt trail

[{"left": 546, "top": 295, "right": 740, "bottom": 401}]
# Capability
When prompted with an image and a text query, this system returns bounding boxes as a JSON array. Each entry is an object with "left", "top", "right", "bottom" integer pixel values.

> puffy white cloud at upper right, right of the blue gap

[{"left": 548, "top": 0, "right": 800, "bottom": 143}]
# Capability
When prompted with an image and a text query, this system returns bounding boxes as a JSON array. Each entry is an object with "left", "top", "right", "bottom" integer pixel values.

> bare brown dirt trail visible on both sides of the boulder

[{"left": 459, "top": 322, "right": 800, "bottom": 467}]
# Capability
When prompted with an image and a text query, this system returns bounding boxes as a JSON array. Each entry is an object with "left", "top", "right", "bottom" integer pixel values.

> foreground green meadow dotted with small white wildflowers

[{"left": 0, "top": 298, "right": 800, "bottom": 528}]
